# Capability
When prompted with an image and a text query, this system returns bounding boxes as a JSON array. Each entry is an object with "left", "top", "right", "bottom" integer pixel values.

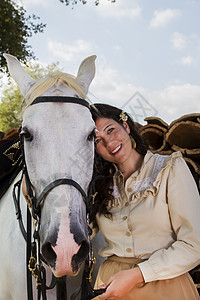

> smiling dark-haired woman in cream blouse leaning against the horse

[{"left": 91, "top": 104, "right": 200, "bottom": 300}]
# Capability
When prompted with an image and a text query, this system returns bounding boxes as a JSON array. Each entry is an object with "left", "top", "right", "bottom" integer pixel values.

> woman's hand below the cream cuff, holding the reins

[{"left": 99, "top": 267, "right": 144, "bottom": 300}]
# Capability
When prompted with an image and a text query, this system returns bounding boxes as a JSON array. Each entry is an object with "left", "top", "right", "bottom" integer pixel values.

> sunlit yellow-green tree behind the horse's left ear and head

[{"left": 0, "top": 62, "right": 61, "bottom": 132}]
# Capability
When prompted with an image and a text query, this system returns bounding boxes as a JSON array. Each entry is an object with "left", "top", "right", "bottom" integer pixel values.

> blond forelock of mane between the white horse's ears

[{"left": 22, "top": 71, "right": 86, "bottom": 109}]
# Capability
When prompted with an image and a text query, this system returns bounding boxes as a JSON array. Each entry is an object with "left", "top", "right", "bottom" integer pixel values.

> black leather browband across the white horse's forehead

[{"left": 31, "top": 96, "right": 90, "bottom": 109}]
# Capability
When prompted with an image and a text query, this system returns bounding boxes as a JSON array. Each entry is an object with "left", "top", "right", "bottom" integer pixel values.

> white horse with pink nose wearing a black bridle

[{"left": 0, "top": 54, "right": 103, "bottom": 300}]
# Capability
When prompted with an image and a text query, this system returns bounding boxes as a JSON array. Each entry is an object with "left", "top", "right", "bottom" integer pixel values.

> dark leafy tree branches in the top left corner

[{"left": 0, "top": 0, "right": 46, "bottom": 68}]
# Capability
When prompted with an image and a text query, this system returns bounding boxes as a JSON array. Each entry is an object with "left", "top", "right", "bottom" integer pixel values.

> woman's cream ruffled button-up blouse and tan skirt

[{"left": 92, "top": 151, "right": 200, "bottom": 300}]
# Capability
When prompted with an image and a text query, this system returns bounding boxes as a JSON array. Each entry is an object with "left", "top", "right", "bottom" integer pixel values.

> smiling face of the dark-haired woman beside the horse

[{"left": 95, "top": 118, "right": 133, "bottom": 164}]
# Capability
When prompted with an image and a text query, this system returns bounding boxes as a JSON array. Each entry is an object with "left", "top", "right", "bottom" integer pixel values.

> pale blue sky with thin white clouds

[{"left": 7, "top": 0, "right": 200, "bottom": 125}]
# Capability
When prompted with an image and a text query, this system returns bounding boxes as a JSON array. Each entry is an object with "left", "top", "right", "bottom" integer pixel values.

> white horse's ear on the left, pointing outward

[{"left": 3, "top": 53, "right": 35, "bottom": 96}]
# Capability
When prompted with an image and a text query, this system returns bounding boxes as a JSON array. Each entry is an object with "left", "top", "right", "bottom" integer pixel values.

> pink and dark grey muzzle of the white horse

[{"left": 41, "top": 213, "right": 89, "bottom": 277}]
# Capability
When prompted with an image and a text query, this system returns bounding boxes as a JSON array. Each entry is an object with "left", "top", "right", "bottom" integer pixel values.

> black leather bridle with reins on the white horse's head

[{"left": 13, "top": 96, "right": 104, "bottom": 300}]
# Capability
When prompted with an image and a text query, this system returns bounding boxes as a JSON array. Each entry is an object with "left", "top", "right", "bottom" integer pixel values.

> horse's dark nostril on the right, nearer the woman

[{"left": 71, "top": 240, "right": 89, "bottom": 273}]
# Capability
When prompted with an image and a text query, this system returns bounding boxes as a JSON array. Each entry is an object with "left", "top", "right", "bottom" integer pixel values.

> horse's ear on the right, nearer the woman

[{"left": 76, "top": 55, "right": 96, "bottom": 94}]
